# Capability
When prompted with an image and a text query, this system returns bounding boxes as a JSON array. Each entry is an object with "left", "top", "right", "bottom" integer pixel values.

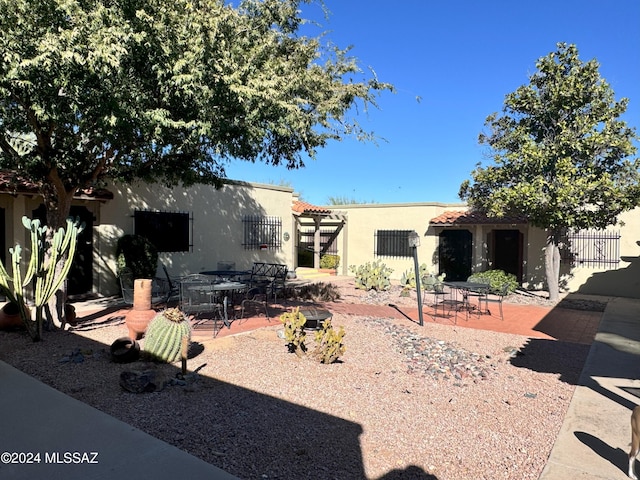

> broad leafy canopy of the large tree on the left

[{"left": 0, "top": 0, "right": 392, "bottom": 224}]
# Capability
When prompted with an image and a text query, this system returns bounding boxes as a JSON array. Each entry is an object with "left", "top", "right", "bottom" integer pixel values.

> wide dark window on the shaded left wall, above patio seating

[{"left": 133, "top": 211, "right": 191, "bottom": 252}]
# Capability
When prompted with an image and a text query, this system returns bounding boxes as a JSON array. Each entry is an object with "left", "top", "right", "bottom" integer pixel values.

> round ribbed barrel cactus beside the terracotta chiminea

[{"left": 144, "top": 308, "right": 191, "bottom": 363}]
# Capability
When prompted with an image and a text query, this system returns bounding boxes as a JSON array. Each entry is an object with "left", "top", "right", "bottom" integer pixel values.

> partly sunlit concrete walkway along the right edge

[{"left": 540, "top": 298, "right": 640, "bottom": 480}]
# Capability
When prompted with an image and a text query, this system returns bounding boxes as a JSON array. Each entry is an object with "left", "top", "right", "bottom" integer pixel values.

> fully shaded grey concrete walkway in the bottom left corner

[{"left": 0, "top": 361, "right": 236, "bottom": 480}]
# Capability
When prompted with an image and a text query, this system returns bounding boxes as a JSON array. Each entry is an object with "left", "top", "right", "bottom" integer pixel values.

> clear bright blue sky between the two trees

[{"left": 227, "top": 0, "right": 640, "bottom": 205}]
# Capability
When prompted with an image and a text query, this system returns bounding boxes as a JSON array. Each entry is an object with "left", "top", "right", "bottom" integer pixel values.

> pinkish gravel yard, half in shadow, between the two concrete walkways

[{"left": 0, "top": 292, "right": 589, "bottom": 480}]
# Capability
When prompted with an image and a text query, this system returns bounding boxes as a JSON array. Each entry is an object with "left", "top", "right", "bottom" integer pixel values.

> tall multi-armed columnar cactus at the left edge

[{"left": 0, "top": 217, "right": 84, "bottom": 341}]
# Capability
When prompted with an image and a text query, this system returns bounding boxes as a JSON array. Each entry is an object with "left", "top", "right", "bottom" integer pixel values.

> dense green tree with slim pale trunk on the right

[{"left": 460, "top": 43, "right": 640, "bottom": 300}]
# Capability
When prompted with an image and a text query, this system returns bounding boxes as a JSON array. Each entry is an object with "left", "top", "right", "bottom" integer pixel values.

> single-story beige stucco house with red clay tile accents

[{"left": 0, "top": 175, "right": 640, "bottom": 298}]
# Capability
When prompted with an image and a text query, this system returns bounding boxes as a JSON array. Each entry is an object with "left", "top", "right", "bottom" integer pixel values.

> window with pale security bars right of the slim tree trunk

[{"left": 561, "top": 230, "right": 620, "bottom": 268}]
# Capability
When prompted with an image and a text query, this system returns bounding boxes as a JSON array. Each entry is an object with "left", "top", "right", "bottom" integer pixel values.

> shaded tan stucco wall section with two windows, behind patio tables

[{"left": 94, "top": 184, "right": 294, "bottom": 294}]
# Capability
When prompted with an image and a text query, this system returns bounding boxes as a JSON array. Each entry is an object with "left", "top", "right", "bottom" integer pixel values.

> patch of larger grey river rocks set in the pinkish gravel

[{"left": 366, "top": 318, "right": 491, "bottom": 381}]
